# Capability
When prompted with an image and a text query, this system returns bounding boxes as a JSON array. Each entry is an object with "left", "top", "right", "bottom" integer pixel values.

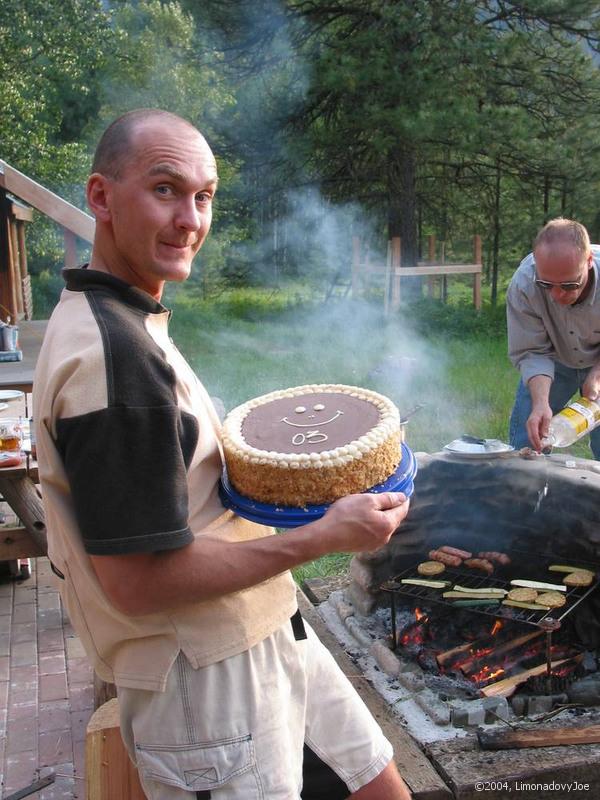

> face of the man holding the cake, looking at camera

[{"left": 99, "top": 120, "right": 217, "bottom": 297}]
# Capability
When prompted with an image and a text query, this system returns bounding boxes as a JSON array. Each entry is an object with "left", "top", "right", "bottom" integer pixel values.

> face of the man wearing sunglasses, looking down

[{"left": 534, "top": 245, "right": 593, "bottom": 306}]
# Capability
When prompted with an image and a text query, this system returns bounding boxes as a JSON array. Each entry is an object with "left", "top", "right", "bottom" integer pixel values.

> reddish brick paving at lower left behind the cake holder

[{"left": 0, "top": 558, "right": 94, "bottom": 800}]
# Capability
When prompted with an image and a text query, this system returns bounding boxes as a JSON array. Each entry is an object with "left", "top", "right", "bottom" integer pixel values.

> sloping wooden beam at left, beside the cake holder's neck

[{"left": 0, "top": 160, "right": 95, "bottom": 242}]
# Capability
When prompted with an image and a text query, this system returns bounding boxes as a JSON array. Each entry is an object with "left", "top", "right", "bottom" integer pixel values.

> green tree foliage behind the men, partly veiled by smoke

[{"left": 5, "top": 0, "right": 600, "bottom": 301}]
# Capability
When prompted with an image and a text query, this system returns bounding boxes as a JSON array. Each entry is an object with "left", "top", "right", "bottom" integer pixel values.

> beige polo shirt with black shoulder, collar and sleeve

[{"left": 34, "top": 268, "right": 296, "bottom": 691}]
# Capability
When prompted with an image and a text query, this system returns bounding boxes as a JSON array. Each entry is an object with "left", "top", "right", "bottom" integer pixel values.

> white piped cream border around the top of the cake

[{"left": 223, "top": 383, "right": 400, "bottom": 469}]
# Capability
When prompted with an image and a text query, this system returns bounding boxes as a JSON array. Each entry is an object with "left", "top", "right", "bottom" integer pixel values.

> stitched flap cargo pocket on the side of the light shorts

[{"left": 136, "top": 734, "right": 263, "bottom": 800}]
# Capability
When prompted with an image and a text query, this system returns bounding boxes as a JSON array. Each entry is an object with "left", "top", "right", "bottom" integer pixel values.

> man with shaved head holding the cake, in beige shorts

[{"left": 34, "top": 109, "right": 410, "bottom": 800}]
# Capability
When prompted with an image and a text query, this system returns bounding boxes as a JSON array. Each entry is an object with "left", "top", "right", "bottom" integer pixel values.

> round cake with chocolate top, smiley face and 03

[{"left": 218, "top": 384, "right": 401, "bottom": 507}]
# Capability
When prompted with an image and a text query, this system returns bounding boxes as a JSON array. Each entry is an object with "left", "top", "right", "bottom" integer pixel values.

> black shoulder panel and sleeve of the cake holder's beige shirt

[{"left": 56, "top": 286, "right": 198, "bottom": 555}]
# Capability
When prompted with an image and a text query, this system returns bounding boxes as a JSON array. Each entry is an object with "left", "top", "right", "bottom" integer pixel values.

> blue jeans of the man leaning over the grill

[{"left": 509, "top": 361, "right": 600, "bottom": 461}]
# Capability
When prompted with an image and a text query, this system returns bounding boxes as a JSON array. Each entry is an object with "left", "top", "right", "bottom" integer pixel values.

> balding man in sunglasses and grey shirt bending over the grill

[{"left": 506, "top": 218, "right": 600, "bottom": 460}]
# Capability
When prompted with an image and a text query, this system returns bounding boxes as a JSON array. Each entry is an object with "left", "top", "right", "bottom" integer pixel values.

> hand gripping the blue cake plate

[{"left": 313, "top": 492, "right": 409, "bottom": 553}]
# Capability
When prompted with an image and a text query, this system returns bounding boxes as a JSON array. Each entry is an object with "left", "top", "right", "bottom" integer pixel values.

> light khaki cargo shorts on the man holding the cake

[{"left": 118, "top": 614, "right": 393, "bottom": 800}]
